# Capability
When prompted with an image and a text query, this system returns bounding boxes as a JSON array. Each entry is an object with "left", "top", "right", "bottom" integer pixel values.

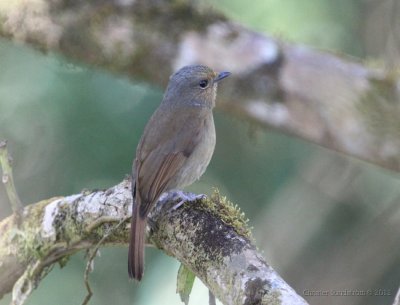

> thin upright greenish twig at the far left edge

[{"left": 0, "top": 141, "right": 22, "bottom": 222}]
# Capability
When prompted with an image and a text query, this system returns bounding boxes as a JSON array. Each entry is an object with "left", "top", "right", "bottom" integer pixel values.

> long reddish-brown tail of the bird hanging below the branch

[{"left": 128, "top": 204, "right": 147, "bottom": 281}]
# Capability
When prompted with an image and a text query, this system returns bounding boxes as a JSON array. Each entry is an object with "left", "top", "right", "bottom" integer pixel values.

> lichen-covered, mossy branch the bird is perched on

[{"left": 0, "top": 181, "right": 307, "bottom": 305}]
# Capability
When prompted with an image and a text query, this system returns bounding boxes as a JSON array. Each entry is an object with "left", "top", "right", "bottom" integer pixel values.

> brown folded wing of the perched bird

[{"left": 135, "top": 109, "right": 205, "bottom": 217}]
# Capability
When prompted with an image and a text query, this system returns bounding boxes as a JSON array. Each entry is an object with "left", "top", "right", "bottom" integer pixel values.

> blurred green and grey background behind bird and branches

[{"left": 0, "top": 0, "right": 400, "bottom": 305}]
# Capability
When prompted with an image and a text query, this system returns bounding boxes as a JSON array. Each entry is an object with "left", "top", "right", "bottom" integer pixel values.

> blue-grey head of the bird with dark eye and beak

[{"left": 164, "top": 65, "right": 231, "bottom": 108}]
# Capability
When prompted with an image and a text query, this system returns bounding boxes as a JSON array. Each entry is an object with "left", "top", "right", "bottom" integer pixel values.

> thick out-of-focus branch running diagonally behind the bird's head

[{"left": 0, "top": 0, "right": 400, "bottom": 171}]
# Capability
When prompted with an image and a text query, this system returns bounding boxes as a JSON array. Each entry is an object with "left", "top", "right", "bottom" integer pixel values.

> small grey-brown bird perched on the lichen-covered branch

[{"left": 128, "top": 65, "right": 230, "bottom": 281}]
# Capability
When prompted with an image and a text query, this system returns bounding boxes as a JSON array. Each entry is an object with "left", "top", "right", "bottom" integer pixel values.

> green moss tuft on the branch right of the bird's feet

[{"left": 193, "top": 188, "right": 254, "bottom": 241}]
